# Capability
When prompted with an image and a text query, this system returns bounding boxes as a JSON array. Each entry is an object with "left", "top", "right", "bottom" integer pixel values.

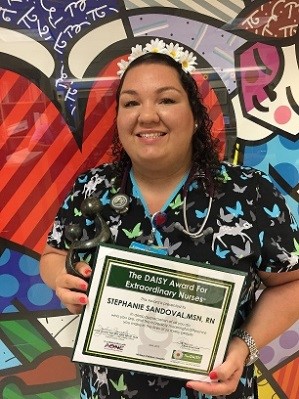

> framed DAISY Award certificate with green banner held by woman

[{"left": 73, "top": 244, "right": 246, "bottom": 380}]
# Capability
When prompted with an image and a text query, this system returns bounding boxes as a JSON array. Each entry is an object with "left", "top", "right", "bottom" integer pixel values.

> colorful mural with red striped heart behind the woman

[{"left": 0, "top": 0, "right": 299, "bottom": 399}]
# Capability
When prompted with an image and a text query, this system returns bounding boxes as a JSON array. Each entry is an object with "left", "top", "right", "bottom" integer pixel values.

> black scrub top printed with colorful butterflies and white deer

[{"left": 48, "top": 163, "right": 299, "bottom": 399}]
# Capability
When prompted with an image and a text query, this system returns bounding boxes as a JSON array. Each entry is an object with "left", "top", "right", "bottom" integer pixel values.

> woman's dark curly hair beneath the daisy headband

[{"left": 112, "top": 53, "right": 220, "bottom": 195}]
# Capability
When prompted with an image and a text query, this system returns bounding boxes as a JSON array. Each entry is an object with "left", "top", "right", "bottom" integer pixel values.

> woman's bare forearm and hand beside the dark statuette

[{"left": 40, "top": 245, "right": 91, "bottom": 314}]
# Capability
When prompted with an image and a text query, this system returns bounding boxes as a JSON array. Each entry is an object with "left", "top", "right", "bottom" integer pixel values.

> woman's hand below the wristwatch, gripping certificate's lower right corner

[{"left": 186, "top": 337, "right": 249, "bottom": 396}]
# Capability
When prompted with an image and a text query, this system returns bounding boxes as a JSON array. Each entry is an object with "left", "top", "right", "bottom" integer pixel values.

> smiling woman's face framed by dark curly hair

[{"left": 117, "top": 64, "right": 195, "bottom": 172}]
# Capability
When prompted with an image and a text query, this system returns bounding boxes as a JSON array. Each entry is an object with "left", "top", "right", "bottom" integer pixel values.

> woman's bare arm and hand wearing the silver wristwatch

[{"left": 187, "top": 270, "right": 299, "bottom": 396}]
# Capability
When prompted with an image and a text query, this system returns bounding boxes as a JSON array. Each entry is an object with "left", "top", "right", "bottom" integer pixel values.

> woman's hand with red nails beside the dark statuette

[{"left": 55, "top": 262, "right": 91, "bottom": 314}]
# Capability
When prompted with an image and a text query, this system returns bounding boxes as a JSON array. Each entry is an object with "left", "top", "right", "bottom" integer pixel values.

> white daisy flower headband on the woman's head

[{"left": 117, "top": 39, "right": 197, "bottom": 78}]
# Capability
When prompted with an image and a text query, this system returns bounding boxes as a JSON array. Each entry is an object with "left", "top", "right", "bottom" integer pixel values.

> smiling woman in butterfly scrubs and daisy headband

[{"left": 40, "top": 39, "right": 299, "bottom": 399}]
